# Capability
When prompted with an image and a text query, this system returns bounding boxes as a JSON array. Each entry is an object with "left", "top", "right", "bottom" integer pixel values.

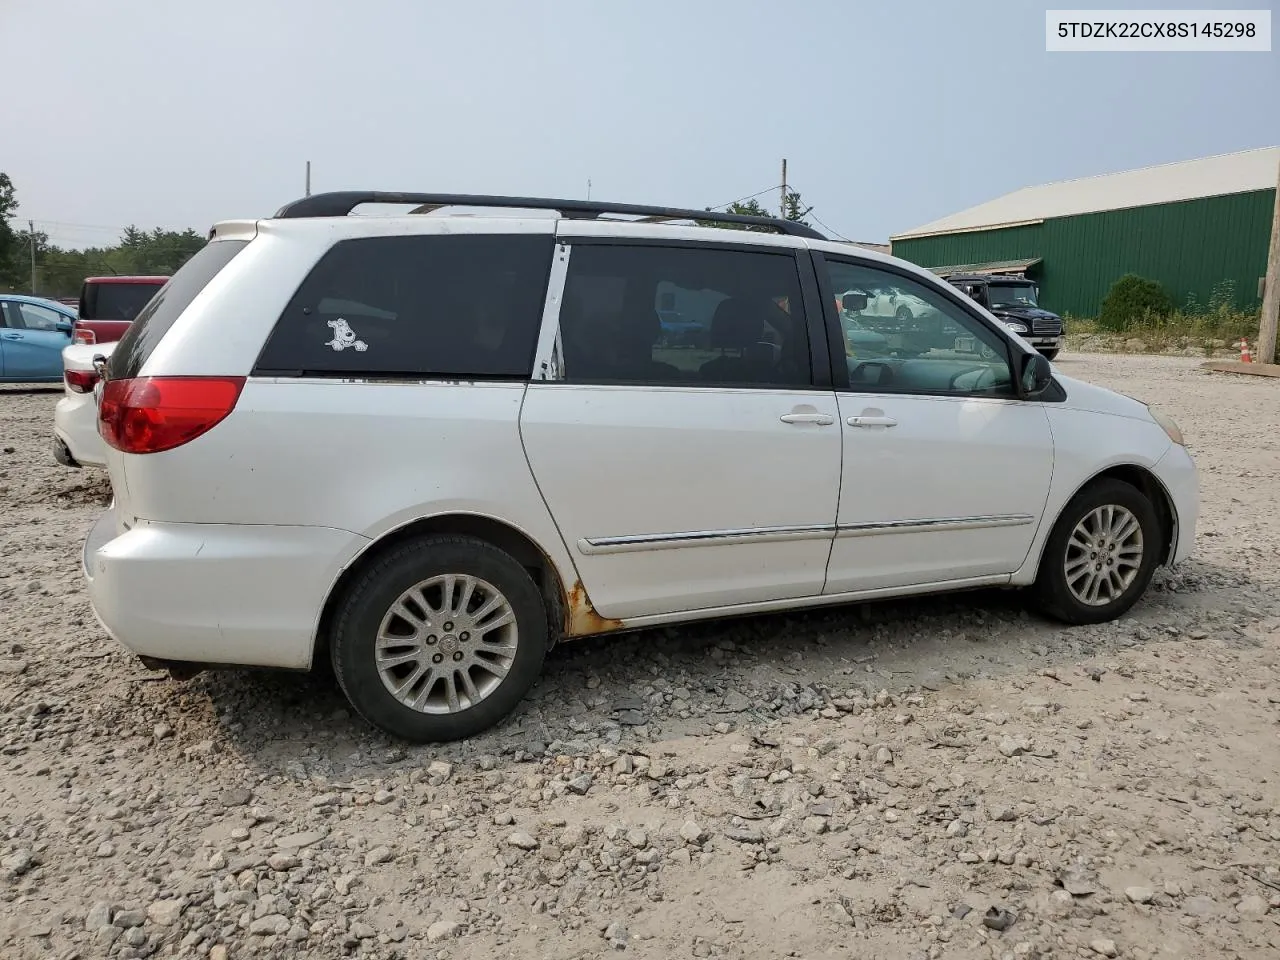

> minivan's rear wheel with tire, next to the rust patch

[{"left": 330, "top": 536, "right": 548, "bottom": 742}]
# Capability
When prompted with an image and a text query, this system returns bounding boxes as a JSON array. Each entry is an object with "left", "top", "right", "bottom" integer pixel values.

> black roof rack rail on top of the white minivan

[{"left": 275, "top": 191, "right": 827, "bottom": 239}]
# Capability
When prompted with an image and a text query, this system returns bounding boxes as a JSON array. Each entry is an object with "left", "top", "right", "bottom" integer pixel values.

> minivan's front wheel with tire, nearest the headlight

[{"left": 1034, "top": 479, "right": 1162, "bottom": 623}]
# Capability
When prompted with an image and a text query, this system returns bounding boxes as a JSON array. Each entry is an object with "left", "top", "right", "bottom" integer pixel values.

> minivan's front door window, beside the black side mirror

[{"left": 826, "top": 260, "right": 1015, "bottom": 397}]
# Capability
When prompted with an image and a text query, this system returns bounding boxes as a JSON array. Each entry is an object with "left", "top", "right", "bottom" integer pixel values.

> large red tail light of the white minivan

[{"left": 97, "top": 376, "right": 244, "bottom": 453}]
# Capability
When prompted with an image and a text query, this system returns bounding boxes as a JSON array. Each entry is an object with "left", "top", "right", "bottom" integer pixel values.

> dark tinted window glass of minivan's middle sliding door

[{"left": 561, "top": 244, "right": 813, "bottom": 388}]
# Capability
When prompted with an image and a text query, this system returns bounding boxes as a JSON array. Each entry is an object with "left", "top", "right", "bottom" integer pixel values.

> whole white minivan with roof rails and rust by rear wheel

[{"left": 83, "top": 192, "right": 1198, "bottom": 741}]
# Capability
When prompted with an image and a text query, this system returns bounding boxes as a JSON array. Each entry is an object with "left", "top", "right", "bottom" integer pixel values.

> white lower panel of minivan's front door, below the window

[{"left": 826, "top": 393, "right": 1053, "bottom": 594}]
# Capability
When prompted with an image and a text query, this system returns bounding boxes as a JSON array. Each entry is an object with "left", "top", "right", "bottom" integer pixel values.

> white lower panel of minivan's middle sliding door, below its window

[{"left": 521, "top": 383, "right": 840, "bottom": 618}]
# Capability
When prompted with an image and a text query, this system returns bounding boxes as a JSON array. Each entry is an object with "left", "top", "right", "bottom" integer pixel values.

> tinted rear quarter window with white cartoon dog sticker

[{"left": 255, "top": 234, "right": 556, "bottom": 379}]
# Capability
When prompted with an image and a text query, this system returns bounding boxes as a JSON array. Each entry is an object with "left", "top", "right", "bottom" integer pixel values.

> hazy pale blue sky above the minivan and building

[{"left": 0, "top": 0, "right": 1280, "bottom": 246}]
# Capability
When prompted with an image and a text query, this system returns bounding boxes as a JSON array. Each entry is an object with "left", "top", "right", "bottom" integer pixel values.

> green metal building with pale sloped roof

[{"left": 890, "top": 147, "right": 1280, "bottom": 316}]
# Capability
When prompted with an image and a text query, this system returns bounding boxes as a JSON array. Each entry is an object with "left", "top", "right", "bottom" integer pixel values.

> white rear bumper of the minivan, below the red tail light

[{"left": 82, "top": 506, "right": 367, "bottom": 669}]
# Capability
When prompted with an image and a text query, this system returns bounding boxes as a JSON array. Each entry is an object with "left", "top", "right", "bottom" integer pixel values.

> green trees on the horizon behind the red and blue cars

[{"left": 0, "top": 173, "right": 207, "bottom": 298}]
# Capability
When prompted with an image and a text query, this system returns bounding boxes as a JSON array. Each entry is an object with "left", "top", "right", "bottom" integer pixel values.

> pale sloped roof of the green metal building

[{"left": 890, "top": 147, "right": 1280, "bottom": 241}]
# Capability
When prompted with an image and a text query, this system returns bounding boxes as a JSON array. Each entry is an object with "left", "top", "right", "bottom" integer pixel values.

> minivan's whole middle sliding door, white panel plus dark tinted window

[{"left": 521, "top": 236, "right": 841, "bottom": 618}]
